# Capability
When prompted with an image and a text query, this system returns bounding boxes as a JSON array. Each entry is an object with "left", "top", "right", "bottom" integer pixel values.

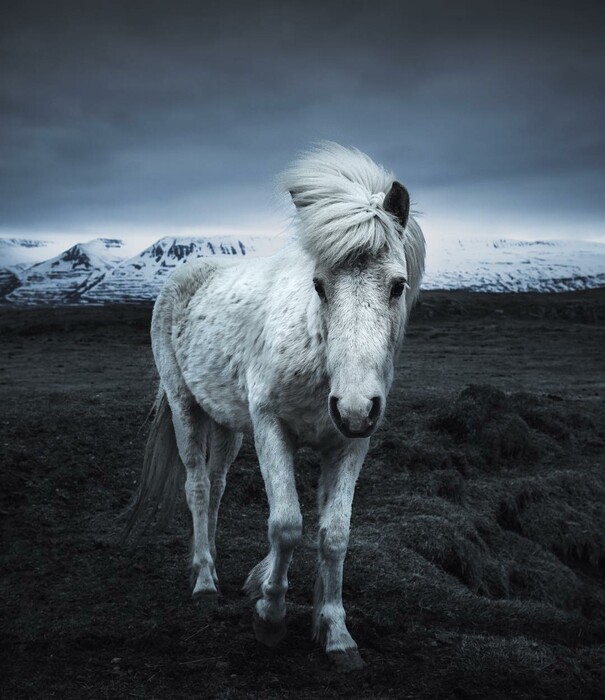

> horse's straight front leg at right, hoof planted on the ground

[{"left": 313, "top": 440, "right": 369, "bottom": 671}]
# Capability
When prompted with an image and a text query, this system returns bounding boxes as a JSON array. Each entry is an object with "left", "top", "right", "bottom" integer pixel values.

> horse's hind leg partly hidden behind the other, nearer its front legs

[{"left": 208, "top": 421, "right": 243, "bottom": 590}]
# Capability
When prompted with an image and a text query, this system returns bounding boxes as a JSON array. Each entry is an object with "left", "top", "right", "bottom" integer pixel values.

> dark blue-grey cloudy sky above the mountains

[{"left": 0, "top": 0, "right": 605, "bottom": 243}]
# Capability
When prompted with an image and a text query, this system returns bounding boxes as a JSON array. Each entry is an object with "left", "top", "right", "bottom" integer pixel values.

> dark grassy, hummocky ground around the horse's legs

[{"left": 0, "top": 289, "right": 605, "bottom": 699}]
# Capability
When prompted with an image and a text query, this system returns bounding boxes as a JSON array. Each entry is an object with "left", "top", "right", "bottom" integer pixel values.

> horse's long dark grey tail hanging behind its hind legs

[{"left": 121, "top": 385, "right": 185, "bottom": 542}]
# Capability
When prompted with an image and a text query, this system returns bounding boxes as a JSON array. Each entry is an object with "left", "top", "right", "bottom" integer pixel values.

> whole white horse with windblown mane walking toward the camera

[{"left": 129, "top": 143, "right": 425, "bottom": 670}]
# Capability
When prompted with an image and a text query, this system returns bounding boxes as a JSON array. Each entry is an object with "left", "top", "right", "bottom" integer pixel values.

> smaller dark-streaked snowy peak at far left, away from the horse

[{"left": 6, "top": 238, "right": 128, "bottom": 304}]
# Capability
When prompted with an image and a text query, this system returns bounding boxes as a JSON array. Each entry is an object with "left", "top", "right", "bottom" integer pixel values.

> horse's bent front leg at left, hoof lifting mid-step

[{"left": 244, "top": 416, "right": 302, "bottom": 646}]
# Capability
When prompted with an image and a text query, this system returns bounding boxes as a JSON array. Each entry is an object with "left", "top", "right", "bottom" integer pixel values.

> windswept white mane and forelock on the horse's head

[{"left": 280, "top": 141, "right": 425, "bottom": 302}]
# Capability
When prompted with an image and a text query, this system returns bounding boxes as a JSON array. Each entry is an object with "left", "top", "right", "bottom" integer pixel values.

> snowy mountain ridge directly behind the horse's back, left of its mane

[{"left": 82, "top": 236, "right": 276, "bottom": 303}]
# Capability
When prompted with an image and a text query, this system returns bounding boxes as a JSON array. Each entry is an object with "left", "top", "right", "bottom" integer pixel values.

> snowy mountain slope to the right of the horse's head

[{"left": 423, "top": 238, "right": 605, "bottom": 292}]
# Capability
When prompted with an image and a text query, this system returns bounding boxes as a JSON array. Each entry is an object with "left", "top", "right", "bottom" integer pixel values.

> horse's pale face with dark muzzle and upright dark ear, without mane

[{"left": 312, "top": 182, "right": 410, "bottom": 438}]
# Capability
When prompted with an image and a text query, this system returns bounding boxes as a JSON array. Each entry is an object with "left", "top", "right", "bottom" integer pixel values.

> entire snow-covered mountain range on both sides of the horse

[{"left": 0, "top": 236, "right": 605, "bottom": 304}]
